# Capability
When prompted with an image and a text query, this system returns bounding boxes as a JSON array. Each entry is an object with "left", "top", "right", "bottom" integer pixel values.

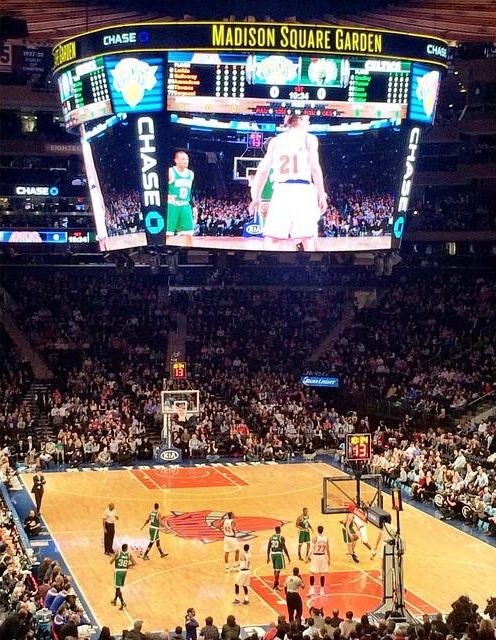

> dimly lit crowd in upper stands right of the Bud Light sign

[{"left": 320, "top": 272, "right": 496, "bottom": 418}]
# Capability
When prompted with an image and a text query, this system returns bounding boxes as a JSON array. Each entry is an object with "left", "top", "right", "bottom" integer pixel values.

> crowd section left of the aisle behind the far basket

[{"left": 1, "top": 274, "right": 176, "bottom": 465}]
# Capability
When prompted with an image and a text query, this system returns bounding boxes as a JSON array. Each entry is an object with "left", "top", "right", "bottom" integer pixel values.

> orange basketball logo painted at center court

[{"left": 160, "top": 509, "right": 286, "bottom": 544}]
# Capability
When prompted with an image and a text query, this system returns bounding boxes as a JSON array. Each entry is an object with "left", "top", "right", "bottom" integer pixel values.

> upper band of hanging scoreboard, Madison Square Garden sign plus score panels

[{"left": 54, "top": 22, "right": 448, "bottom": 129}]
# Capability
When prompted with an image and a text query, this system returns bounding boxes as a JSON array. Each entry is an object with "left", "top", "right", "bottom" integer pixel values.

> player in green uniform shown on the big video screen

[{"left": 166, "top": 151, "right": 195, "bottom": 236}]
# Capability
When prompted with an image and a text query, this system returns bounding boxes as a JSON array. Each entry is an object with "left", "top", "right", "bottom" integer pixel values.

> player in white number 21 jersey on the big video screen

[{"left": 250, "top": 114, "right": 327, "bottom": 251}]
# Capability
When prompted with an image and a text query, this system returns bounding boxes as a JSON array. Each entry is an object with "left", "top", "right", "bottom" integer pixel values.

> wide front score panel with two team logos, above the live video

[{"left": 167, "top": 52, "right": 411, "bottom": 118}]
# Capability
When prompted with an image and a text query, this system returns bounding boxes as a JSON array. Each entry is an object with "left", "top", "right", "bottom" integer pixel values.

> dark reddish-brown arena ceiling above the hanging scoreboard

[{"left": 2, "top": 0, "right": 496, "bottom": 43}]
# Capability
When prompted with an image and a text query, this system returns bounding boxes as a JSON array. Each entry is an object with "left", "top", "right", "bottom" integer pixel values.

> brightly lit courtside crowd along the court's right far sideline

[{"left": 369, "top": 418, "right": 496, "bottom": 536}]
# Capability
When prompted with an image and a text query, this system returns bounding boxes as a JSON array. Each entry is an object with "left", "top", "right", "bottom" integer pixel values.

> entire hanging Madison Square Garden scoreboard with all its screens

[{"left": 54, "top": 21, "right": 448, "bottom": 252}]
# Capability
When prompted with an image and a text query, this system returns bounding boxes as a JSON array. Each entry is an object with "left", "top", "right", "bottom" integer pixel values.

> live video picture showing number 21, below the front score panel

[{"left": 166, "top": 113, "right": 406, "bottom": 251}]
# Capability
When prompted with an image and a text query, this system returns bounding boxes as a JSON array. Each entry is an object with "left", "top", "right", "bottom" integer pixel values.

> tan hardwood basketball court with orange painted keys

[{"left": 22, "top": 462, "right": 496, "bottom": 633}]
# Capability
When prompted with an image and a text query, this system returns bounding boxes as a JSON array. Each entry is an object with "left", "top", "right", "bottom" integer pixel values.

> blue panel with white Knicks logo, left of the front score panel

[{"left": 105, "top": 56, "right": 164, "bottom": 113}]
